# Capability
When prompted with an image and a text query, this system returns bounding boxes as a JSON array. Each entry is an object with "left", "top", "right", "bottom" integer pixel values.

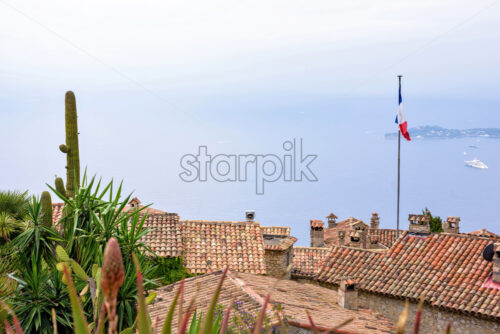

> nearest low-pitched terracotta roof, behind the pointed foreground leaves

[{"left": 149, "top": 272, "right": 394, "bottom": 334}]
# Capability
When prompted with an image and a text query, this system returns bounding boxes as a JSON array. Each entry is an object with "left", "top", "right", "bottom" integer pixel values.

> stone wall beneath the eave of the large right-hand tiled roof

[{"left": 358, "top": 291, "right": 500, "bottom": 334}]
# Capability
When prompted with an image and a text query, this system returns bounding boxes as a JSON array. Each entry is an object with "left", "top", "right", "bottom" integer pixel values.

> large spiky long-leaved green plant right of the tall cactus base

[{"left": 49, "top": 173, "right": 170, "bottom": 330}]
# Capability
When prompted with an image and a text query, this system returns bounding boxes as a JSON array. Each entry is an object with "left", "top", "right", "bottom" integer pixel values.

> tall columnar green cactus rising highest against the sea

[{"left": 59, "top": 91, "right": 80, "bottom": 197}]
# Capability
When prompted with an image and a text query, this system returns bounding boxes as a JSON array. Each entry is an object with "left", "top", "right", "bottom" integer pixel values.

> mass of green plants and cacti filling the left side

[{"left": 0, "top": 92, "right": 192, "bottom": 333}]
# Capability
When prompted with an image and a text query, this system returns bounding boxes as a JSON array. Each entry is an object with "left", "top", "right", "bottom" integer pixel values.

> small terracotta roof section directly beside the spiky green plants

[{"left": 141, "top": 213, "right": 182, "bottom": 257}]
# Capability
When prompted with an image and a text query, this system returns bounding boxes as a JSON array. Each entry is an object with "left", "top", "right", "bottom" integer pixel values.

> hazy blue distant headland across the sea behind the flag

[{"left": 385, "top": 125, "right": 500, "bottom": 139}]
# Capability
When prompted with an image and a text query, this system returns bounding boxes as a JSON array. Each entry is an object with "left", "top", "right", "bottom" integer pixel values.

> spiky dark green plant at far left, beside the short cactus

[{"left": 9, "top": 197, "right": 71, "bottom": 333}]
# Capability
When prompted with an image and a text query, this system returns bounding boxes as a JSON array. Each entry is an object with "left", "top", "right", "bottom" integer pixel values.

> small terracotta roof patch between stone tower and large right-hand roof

[{"left": 292, "top": 247, "right": 329, "bottom": 278}]
